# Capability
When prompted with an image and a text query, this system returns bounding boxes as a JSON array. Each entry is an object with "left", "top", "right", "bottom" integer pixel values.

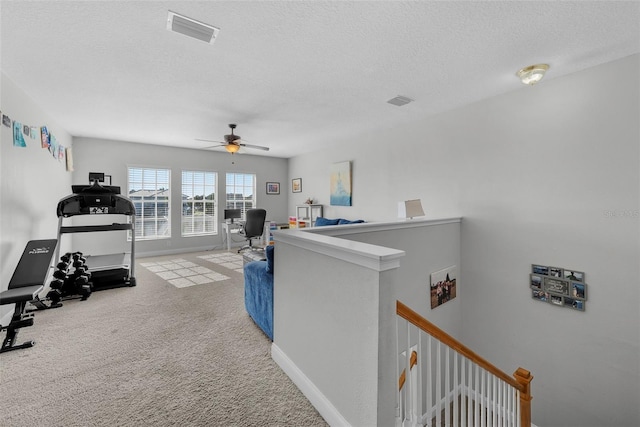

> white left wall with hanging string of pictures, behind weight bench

[{"left": 0, "top": 73, "right": 72, "bottom": 325}]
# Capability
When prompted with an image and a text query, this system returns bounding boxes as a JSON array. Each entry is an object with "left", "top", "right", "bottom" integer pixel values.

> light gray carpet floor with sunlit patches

[{"left": 0, "top": 252, "right": 327, "bottom": 427}]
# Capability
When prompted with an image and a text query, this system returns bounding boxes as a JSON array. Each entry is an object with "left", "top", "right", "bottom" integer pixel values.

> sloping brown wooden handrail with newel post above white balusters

[{"left": 396, "top": 301, "right": 533, "bottom": 398}]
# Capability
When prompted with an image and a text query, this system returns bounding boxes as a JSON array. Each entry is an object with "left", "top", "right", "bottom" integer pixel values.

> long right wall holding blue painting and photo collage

[{"left": 289, "top": 55, "right": 640, "bottom": 426}]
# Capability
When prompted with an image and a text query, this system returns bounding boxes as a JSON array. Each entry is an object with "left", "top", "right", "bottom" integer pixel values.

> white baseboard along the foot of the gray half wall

[{"left": 271, "top": 343, "right": 351, "bottom": 427}]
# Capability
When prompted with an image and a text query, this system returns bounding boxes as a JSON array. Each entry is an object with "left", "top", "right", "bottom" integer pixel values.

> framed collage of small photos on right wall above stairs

[{"left": 529, "top": 264, "right": 587, "bottom": 311}]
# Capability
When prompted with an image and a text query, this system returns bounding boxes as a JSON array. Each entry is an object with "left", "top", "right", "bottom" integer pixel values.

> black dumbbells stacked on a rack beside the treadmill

[{"left": 47, "top": 252, "right": 93, "bottom": 304}]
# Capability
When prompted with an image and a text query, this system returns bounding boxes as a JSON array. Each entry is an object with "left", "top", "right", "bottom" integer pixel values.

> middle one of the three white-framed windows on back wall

[{"left": 182, "top": 171, "right": 218, "bottom": 236}]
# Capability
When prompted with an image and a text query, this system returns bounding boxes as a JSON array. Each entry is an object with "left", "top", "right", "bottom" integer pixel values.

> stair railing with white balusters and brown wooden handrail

[{"left": 396, "top": 301, "right": 533, "bottom": 427}]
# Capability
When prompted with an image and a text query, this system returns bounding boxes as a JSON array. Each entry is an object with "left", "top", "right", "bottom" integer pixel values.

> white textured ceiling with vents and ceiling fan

[{"left": 0, "top": 0, "right": 640, "bottom": 157}]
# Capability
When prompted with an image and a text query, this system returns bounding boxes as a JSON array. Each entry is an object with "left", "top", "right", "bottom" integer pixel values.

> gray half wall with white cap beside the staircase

[{"left": 272, "top": 218, "right": 462, "bottom": 426}]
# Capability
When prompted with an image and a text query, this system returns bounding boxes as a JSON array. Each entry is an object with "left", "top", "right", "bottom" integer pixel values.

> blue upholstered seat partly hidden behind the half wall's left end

[{"left": 244, "top": 246, "right": 273, "bottom": 341}]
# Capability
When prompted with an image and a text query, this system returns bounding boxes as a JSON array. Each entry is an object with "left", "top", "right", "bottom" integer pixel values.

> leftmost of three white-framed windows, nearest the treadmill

[{"left": 129, "top": 168, "right": 171, "bottom": 240}]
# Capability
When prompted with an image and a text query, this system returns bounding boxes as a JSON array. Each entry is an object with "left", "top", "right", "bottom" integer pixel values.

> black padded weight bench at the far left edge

[{"left": 0, "top": 239, "right": 58, "bottom": 353}]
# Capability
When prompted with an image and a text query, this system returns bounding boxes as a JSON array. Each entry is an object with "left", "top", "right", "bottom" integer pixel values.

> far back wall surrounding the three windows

[{"left": 73, "top": 138, "right": 288, "bottom": 256}]
